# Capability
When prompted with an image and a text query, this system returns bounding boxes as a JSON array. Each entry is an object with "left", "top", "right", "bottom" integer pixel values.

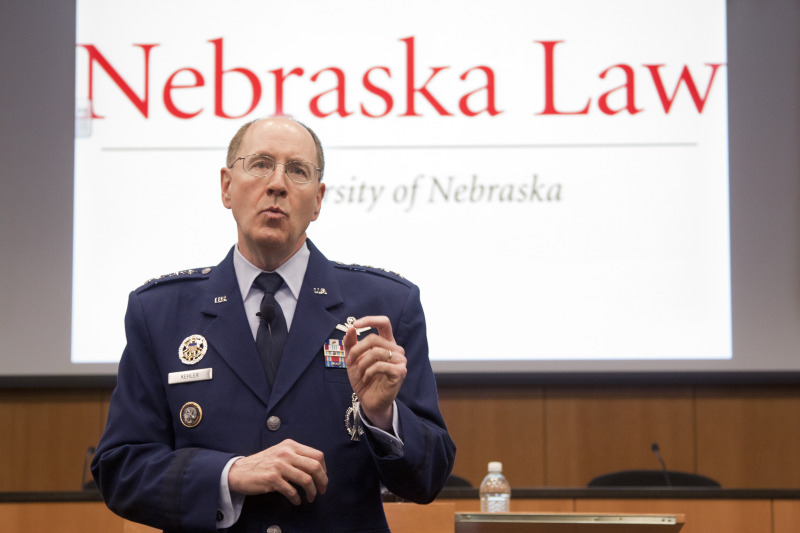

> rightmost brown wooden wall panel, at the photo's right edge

[{"left": 697, "top": 386, "right": 800, "bottom": 488}]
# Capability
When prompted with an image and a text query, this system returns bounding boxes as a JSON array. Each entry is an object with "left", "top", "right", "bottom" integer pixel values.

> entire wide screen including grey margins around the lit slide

[{"left": 0, "top": 0, "right": 800, "bottom": 377}]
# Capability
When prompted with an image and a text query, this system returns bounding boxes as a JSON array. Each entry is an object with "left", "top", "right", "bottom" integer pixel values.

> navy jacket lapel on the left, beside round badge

[{"left": 201, "top": 249, "right": 269, "bottom": 405}]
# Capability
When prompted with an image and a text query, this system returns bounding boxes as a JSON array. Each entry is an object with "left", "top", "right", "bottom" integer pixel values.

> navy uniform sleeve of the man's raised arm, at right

[{"left": 366, "top": 285, "right": 456, "bottom": 503}]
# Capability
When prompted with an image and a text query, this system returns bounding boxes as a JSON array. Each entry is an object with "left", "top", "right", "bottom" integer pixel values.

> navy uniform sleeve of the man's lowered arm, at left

[{"left": 92, "top": 293, "right": 233, "bottom": 532}]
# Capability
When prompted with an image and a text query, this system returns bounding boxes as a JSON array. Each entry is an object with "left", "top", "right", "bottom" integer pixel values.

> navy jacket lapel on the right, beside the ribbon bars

[{"left": 269, "top": 241, "right": 342, "bottom": 409}]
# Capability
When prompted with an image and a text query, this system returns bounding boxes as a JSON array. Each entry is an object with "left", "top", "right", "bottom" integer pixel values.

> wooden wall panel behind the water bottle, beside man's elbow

[{"left": 439, "top": 387, "right": 545, "bottom": 487}]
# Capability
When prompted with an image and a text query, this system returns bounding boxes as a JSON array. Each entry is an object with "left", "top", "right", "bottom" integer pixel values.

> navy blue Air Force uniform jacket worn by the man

[{"left": 92, "top": 242, "right": 455, "bottom": 533}]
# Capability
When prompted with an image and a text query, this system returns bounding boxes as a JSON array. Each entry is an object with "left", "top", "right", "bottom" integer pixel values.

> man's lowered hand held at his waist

[{"left": 228, "top": 439, "right": 328, "bottom": 505}]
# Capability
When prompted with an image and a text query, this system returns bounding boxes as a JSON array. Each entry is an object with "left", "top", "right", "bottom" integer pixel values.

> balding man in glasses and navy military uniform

[{"left": 92, "top": 117, "right": 455, "bottom": 533}]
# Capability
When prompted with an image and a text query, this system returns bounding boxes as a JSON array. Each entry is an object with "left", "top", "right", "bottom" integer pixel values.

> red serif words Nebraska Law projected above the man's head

[{"left": 77, "top": 36, "right": 725, "bottom": 120}]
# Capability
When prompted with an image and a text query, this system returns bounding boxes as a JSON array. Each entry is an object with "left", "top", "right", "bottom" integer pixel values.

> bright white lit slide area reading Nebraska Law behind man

[{"left": 72, "top": 0, "right": 732, "bottom": 362}]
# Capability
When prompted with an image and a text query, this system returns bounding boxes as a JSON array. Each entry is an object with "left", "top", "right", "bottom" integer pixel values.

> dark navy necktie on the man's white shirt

[{"left": 253, "top": 272, "right": 289, "bottom": 388}]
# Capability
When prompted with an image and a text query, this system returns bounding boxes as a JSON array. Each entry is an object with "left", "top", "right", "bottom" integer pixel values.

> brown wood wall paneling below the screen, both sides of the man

[{"left": 0, "top": 385, "right": 800, "bottom": 492}]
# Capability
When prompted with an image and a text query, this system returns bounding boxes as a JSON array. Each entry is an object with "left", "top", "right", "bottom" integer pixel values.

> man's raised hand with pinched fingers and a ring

[{"left": 343, "top": 316, "right": 407, "bottom": 432}]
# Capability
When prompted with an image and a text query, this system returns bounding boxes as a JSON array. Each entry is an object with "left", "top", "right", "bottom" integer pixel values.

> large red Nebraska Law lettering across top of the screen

[{"left": 77, "top": 36, "right": 725, "bottom": 119}]
